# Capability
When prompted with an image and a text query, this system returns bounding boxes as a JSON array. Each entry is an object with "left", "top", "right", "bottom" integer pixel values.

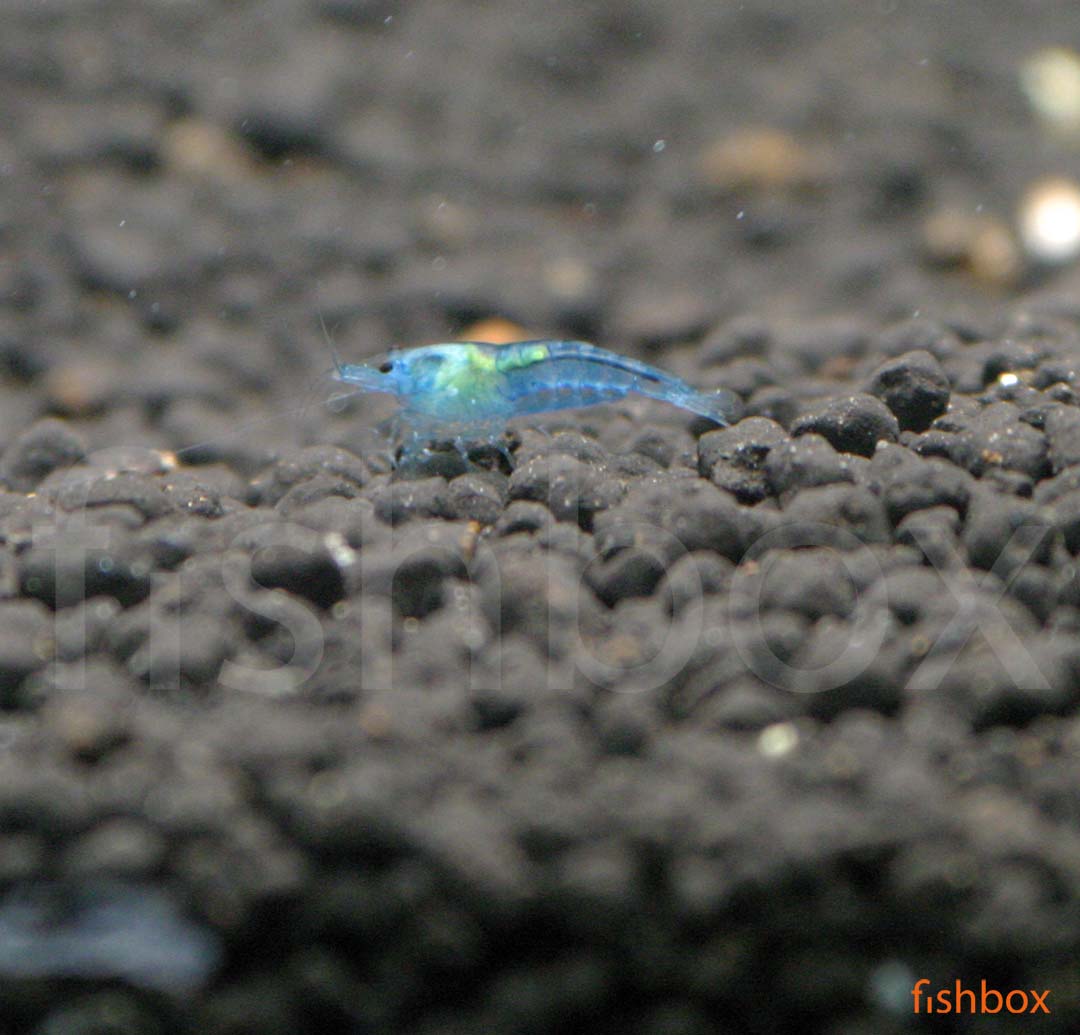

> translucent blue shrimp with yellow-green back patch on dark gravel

[{"left": 335, "top": 340, "right": 739, "bottom": 458}]
